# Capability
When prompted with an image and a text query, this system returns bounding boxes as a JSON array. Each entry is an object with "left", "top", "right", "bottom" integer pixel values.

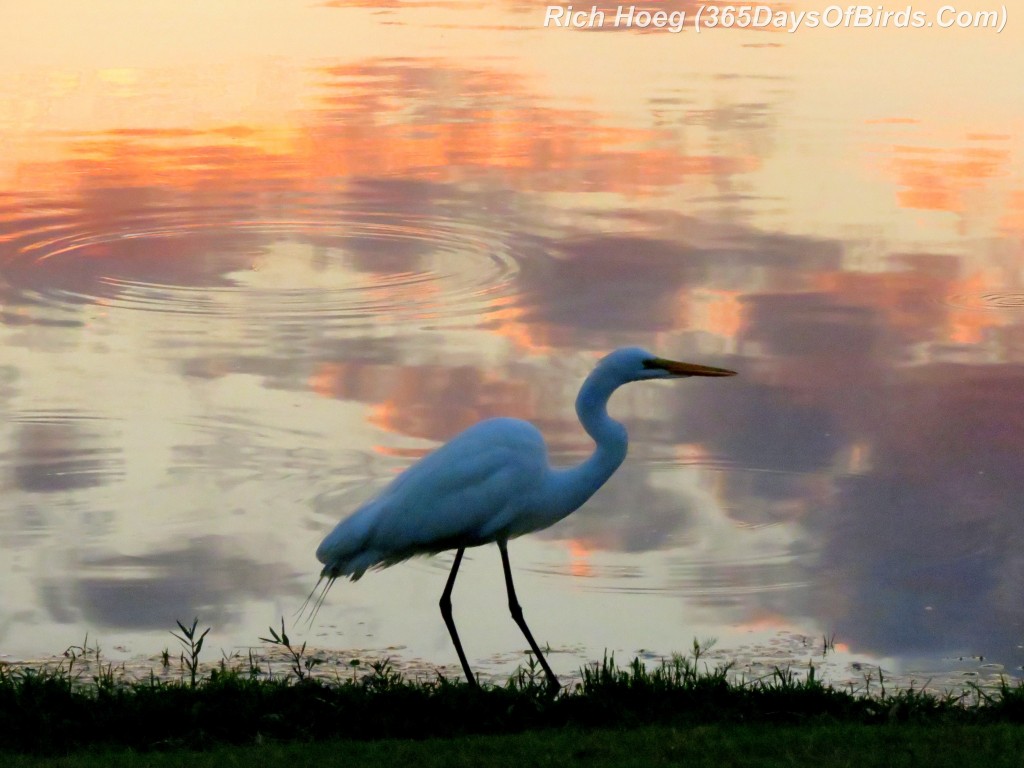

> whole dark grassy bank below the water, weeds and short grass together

[{"left": 0, "top": 621, "right": 1024, "bottom": 765}]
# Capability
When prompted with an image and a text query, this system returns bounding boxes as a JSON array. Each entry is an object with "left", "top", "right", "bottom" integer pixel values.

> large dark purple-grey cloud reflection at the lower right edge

[{"left": 819, "top": 366, "right": 1024, "bottom": 651}]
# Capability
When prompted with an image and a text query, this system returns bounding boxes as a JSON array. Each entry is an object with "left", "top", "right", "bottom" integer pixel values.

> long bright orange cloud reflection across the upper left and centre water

[{"left": 6, "top": 60, "right": 759, "bottom": 224}]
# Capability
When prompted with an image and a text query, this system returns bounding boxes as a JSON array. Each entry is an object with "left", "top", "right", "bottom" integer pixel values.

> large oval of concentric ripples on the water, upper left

[{"left": 0, "top": 209, "right": 517, "bottom": 325}]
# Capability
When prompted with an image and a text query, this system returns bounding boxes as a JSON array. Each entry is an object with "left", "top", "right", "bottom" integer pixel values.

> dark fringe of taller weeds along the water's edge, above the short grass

[{"left": 0, "top": 618, "right": 1024, "bottom": 753}]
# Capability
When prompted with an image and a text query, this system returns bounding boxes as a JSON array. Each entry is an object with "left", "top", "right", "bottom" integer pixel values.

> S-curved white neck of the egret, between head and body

[{"left": 552, "top": 371, "right": 629, "bottom": 517}]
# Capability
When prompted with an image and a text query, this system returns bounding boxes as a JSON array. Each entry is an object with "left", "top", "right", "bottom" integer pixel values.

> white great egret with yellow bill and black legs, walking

[{"left": 310, "top": 347, "right": 735, "bottom": 688}]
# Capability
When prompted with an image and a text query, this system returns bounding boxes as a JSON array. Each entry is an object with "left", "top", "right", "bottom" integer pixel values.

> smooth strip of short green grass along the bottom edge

[{"left": 4, "top": 724, "right": 1024, "bottom": 768}]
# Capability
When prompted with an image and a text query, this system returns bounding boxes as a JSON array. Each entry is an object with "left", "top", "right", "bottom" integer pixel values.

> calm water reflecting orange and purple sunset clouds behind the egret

[{"left": 0, "top": 0, "right": 1024, "bottom": 679}]
